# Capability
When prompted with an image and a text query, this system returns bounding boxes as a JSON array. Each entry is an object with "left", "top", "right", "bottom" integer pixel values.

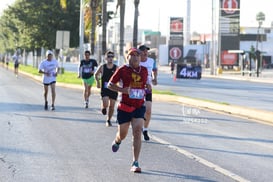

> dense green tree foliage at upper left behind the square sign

[{"left": 0, "top": 0, "right": 80, "bottom": 52}]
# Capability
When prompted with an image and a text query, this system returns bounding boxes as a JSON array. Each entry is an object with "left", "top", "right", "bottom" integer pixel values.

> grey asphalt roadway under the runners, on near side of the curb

[{"left": 0, "top": 64, "right": 273, "bottom": 182}]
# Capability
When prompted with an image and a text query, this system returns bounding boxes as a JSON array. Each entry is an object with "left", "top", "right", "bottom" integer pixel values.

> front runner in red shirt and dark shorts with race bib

[{"left": 108, "top": 48, "right": 151, "bottom": 172}]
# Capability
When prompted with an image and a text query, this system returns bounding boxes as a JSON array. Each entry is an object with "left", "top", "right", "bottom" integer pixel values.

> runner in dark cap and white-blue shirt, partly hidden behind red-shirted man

[{"left": 138, "top": 45, "right": 157, "bottom": 141}]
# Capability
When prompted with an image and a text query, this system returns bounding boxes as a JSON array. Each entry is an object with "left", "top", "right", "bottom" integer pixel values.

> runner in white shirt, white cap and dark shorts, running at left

[{"left": 39, "top": 50, "right": 59, "bottom": 110}]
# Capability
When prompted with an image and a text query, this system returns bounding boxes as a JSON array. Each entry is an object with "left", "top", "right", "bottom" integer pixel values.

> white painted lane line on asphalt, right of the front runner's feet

[{"left": 151, "top": 135, "right": 250, "bottom": 182}]
